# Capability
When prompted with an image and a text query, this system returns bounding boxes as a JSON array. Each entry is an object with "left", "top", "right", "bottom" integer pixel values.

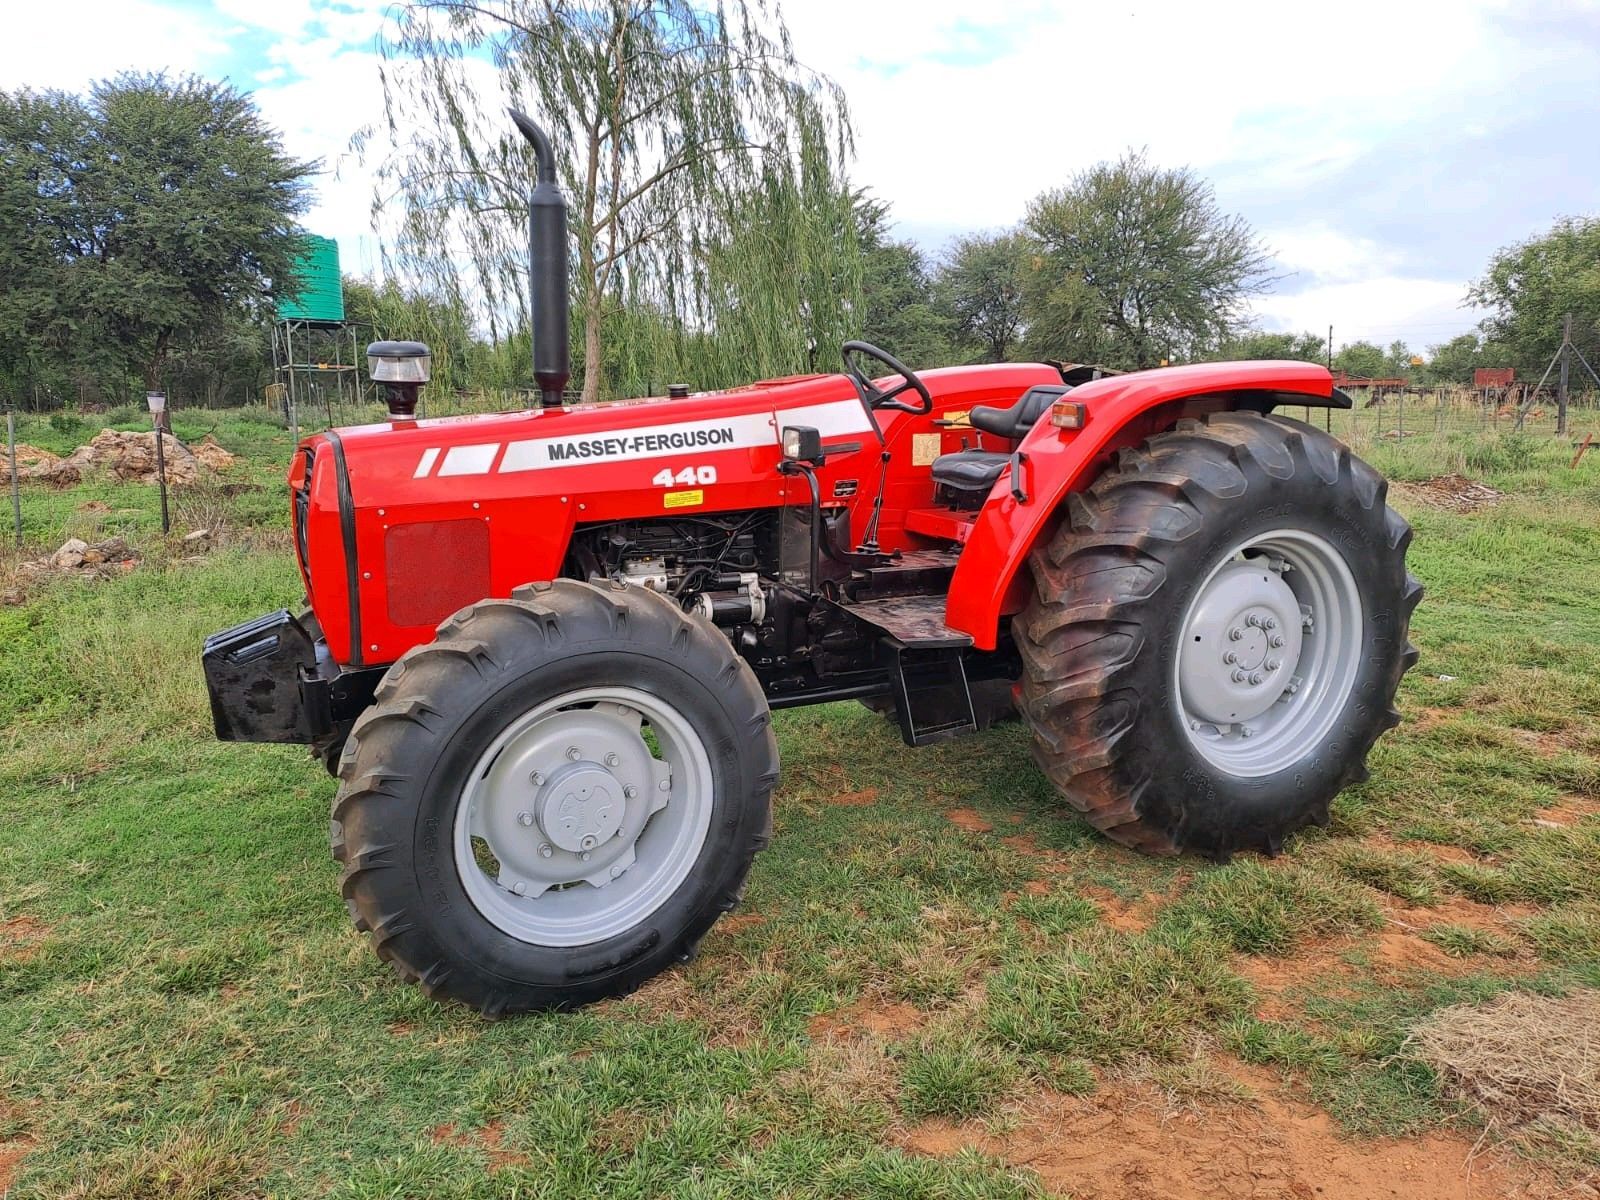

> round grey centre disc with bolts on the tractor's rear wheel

[{"left": 1178, "top": 558, "right": 1302, "bottom": 728}]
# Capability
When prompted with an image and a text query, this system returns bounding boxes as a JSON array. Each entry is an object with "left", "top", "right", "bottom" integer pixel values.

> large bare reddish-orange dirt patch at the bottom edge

[{"left": 901, "top": 1077, "right": 1554, "bottom": 1200}]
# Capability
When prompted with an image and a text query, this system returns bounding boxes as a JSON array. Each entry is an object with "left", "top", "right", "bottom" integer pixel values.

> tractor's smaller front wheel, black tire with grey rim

[{"left": 331, "top": 579, "right": 778, "bottom": 1014}]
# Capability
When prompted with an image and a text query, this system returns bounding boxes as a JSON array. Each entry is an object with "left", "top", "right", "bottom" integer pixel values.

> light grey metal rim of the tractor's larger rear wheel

[{"left": 1173, "top": 530, "right": 1365, "bottom": 778}]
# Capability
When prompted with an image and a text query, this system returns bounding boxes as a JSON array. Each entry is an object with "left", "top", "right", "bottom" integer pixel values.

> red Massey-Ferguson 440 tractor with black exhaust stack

[{"left": 203, "top": 114, "right": 1421, "bottom": 1014}]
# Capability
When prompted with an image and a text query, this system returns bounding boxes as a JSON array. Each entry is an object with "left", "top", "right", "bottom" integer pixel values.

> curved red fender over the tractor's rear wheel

[{"left": 944, "top": 362, "right": 1350, "bottom": 650}]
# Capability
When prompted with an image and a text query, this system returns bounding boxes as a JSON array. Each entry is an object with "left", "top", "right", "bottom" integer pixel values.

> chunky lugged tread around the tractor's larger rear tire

[{"left": 1013, "top": 411, "right": 1422, "bottom": 859}]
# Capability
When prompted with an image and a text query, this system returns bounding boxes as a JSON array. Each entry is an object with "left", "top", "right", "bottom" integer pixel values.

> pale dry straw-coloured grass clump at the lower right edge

[{"left": 1408, "top": 990, "right": 1600, "bottom": 1142}]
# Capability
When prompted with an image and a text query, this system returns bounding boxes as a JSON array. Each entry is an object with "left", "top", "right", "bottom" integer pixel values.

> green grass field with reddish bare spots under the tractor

[{"left": 0, "top": 404, "right": 1600, "bottom": 1200}]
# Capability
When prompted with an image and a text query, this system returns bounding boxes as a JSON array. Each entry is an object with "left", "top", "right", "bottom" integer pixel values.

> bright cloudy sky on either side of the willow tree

[{"left": 0, "top": 0, "right": 1600, "bottom": 350}]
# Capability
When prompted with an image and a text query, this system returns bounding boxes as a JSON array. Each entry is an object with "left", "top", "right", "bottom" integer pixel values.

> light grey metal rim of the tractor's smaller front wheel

[{"left": 454, "top": 686, "right": 712, "bottom": 946}]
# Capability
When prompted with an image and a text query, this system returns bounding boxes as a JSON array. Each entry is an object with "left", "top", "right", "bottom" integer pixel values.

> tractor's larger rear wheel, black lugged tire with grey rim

[{"left": 1013, "top": 413, "right": 1422, "bottom": 859}]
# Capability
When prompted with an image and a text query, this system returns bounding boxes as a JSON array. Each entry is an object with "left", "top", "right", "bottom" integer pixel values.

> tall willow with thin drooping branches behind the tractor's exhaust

[{"left": 366, "top": 0, "right": 850, "bottom": 400}]
